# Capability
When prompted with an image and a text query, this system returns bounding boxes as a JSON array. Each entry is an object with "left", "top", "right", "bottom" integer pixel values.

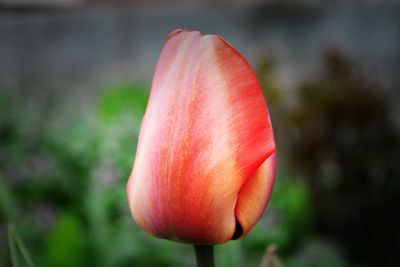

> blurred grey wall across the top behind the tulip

[{"left": 0, "top": 4, "right": 400, "bottom": 101}]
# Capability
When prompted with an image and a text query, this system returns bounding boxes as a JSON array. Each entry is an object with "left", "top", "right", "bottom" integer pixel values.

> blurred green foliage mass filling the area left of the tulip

[{"left": 0, "top": 84, "right": 193, "bottom": 267}]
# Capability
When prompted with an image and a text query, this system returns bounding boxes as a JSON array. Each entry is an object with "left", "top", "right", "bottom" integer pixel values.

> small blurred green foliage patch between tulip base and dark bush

[{"left": 242, "top": 175, "right": 314, "bottom": 266}]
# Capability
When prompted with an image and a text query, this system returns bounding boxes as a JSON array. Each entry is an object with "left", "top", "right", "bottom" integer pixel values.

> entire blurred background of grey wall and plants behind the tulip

[{"left": 0, "top": 0, "right": 400, "bottom": 267}]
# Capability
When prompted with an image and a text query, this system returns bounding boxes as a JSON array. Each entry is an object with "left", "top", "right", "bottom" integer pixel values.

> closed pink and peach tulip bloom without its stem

[{"left": 127, "top": 30, "right": 276, "bottom": 244}]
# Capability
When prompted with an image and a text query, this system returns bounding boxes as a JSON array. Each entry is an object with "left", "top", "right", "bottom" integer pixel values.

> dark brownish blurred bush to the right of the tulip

[{"left": 286, "top": 51, "right": 400, "bottom": 266}]
